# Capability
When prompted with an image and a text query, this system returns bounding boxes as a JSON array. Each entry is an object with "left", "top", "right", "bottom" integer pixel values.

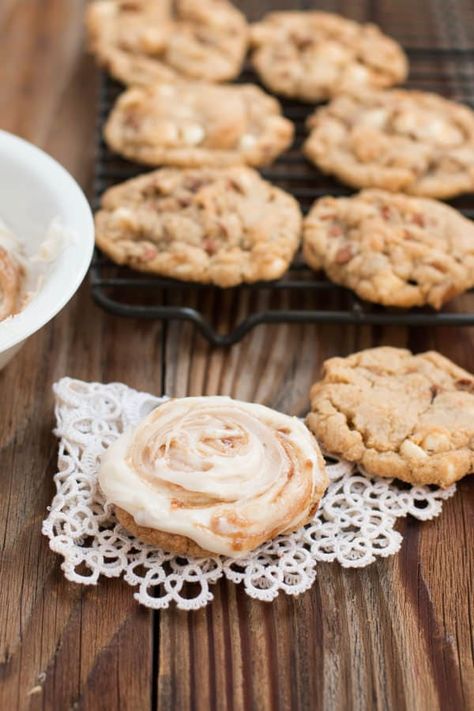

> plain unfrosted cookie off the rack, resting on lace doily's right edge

[{"left": 307, "top": 347, "right": 474, "bottom": 487}]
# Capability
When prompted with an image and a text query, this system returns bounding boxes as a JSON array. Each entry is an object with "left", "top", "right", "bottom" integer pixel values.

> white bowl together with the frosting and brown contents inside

[{"left": 0, "top": 131, "right": 94, "bottom": 368}]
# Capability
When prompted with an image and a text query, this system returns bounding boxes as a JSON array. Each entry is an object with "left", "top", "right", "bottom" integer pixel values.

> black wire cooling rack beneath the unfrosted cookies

[{"left": 91, "top": 40, "right": 474, "bottom": 346}]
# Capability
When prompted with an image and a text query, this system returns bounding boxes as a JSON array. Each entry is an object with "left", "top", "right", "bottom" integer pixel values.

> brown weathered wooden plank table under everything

[{"left": 0, "top": 0, "right": 474, "bottom": 711}]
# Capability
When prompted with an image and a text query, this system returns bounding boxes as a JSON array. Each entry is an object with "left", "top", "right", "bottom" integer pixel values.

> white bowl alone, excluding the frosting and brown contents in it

[{"left": 0, "top": 131, "right": 94, "bottom": 368}]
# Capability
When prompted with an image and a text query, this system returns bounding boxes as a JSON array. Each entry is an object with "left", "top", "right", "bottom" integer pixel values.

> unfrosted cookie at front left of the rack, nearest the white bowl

[{"left": 96, "top": 167, "right": 301, "bottom": 287}]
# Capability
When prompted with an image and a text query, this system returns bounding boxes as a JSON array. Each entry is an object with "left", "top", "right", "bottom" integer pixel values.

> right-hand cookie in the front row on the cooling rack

[{"left": 303, "top": 190, "right": 474, "bottom": 309}]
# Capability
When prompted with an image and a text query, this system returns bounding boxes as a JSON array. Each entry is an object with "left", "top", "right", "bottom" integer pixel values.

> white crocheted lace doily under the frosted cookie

[{"left": 43, "top": 378, "right": 455, "bottom": 609}]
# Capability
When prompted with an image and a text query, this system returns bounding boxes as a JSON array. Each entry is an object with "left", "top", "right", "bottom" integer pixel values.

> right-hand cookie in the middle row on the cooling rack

[{"left": 304, "top": 90, "right": 474, "bottom": 198}]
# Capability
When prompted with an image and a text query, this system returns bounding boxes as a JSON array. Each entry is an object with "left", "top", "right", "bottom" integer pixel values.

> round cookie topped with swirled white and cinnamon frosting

[{"left": 99, "top": 397, "right": 328, "bottom": 557}]
